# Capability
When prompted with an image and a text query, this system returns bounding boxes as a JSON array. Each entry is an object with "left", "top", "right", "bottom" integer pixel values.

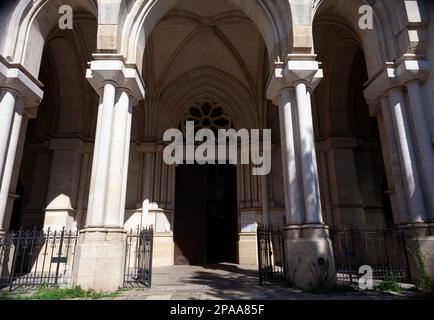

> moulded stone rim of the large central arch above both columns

[{"left": 119, "top": 0, "right": 293, "bottom": 70}]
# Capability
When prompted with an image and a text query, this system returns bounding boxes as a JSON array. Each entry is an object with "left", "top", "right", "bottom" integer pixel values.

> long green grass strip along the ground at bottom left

[{"left": 1, "top": 285, "right": 124, "bottom": 300}]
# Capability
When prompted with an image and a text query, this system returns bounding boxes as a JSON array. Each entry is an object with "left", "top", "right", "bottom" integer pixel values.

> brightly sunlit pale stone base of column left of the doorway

[{"left": 72, "top": 227, "right": 127, "bottom": 292}]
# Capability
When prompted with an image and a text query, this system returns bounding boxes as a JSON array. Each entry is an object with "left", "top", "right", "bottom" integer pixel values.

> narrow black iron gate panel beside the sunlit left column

[{"left": 124, "top": 227, "right": 154, "bottom": 288}]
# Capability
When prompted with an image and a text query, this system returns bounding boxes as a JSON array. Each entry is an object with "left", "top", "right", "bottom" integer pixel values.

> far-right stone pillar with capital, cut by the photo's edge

[{"left": 365, "top": 55, "right": 434, "bottom": 288}]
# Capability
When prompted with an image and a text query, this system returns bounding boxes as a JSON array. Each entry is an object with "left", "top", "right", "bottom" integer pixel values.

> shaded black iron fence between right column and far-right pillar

[{"left": 330, "top": 228, "right": 410, "bottom": 284}]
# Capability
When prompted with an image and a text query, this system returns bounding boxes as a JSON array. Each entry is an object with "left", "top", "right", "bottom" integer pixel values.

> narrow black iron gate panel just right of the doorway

[{"left": 257, "top": 225, "right": 285, "bottom": 285}]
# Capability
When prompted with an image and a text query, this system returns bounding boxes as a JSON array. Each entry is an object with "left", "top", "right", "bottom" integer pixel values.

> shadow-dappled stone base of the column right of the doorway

[{"left": 283, "top": 224, "right": 336, "bottom": 290}]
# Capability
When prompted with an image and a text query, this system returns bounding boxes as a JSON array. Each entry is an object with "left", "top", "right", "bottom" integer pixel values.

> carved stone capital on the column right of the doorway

[{"left": 267, "top": 54, "right": 323, "bottom": 104}]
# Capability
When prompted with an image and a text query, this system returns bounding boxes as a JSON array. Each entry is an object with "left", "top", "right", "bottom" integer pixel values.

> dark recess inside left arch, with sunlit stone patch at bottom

[{"left": 12, "top": 11, "right": 98, "bottom": 229}]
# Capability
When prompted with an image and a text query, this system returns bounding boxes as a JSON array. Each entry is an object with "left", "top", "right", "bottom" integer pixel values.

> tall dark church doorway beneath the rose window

[{"left": 174, "top": 165, "right": 238, "bottom": 265}]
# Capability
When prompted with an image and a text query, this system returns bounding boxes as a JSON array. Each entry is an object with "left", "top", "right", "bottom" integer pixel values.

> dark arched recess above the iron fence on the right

[{"left": 313, "top": 1, "right": 396, "bottom": 228}]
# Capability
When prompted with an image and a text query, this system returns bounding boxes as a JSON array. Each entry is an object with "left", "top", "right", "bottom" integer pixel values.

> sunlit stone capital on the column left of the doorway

[{"left": 86, "top": 53, "right": 145, "bottom": 102}]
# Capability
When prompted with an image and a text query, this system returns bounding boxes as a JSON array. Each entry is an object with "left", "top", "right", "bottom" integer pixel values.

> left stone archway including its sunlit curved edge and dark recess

[{"left": 2, "top": 1, "right": 97, "bottom": 229}]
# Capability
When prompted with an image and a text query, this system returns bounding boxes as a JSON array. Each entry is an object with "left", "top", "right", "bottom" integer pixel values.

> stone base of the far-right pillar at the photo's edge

[{"left": 401, "top": 223, "right": 434, "bottom": 290}]
